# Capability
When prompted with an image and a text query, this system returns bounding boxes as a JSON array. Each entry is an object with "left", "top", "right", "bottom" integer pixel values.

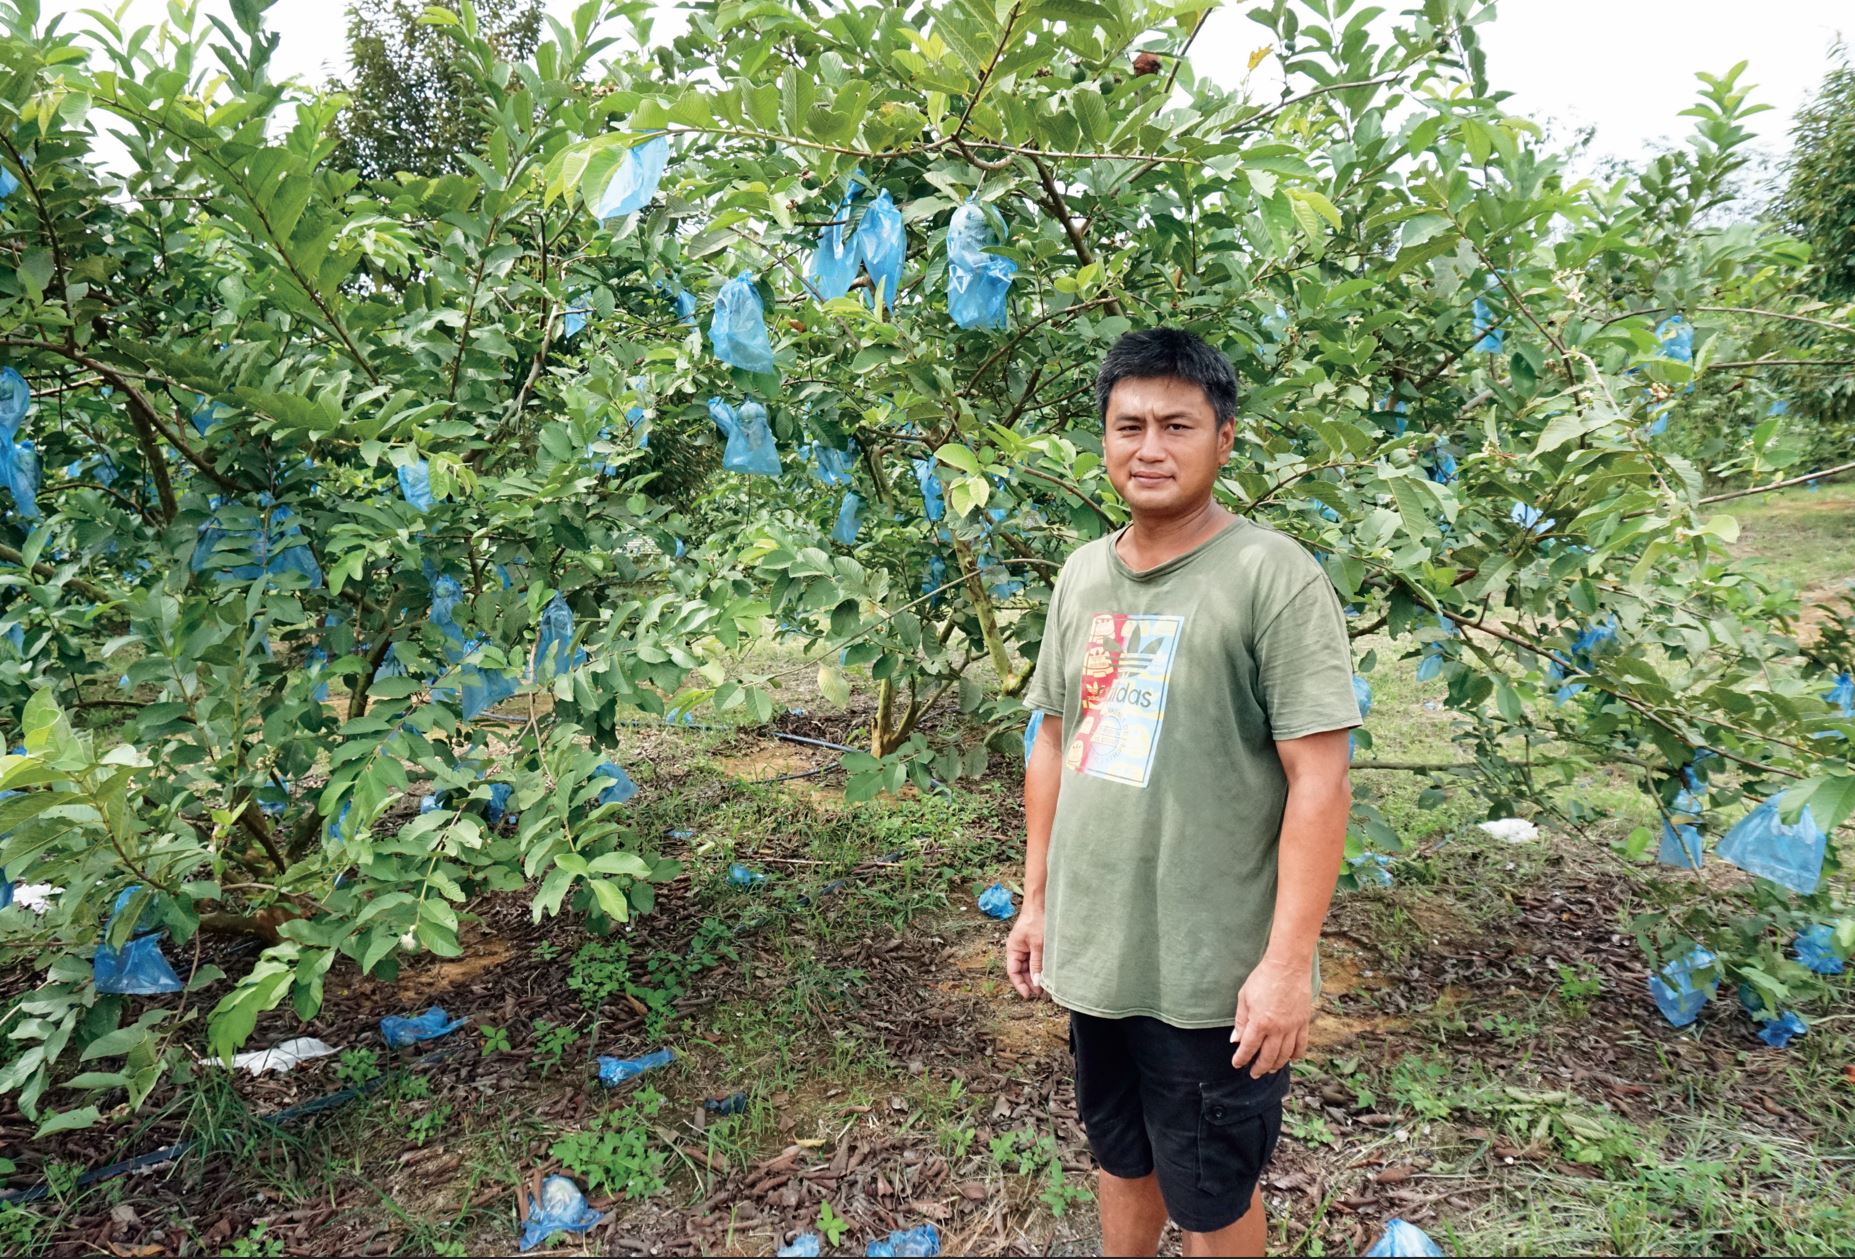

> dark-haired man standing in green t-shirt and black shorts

[{"left": 1005, "top": 328, "right": 1360, "bottom": 1255}]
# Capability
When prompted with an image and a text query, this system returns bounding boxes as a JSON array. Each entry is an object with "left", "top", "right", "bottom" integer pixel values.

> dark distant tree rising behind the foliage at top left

[{"left": 330, "top": 0, "right": 542, "bottom": 180}]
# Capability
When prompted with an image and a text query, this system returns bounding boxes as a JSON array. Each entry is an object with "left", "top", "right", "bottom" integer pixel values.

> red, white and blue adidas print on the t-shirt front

[{"left": 1063, "top": 612, "right": 1185, "bottom": 786}]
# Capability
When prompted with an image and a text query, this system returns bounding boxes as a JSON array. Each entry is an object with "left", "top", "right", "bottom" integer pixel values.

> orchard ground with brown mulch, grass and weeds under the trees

[{"left": 0, "top": 484, "right": 1855, "bottom": 1255}]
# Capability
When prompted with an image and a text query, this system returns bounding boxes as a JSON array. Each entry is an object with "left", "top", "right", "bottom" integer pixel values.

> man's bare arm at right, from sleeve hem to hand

[{"left": 1230, "top": 731, "right": 1352, "bottom": 1077}]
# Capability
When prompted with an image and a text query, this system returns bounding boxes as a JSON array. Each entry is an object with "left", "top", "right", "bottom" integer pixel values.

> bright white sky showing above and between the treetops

[{"left": 45, "top": 0, "right": 1855, "bottom": 179}]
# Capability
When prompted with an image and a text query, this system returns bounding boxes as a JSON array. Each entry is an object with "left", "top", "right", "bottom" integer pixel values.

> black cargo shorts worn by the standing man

[{"left": 1068, "top": 1011, "right": 1289, "bottom": 1233}]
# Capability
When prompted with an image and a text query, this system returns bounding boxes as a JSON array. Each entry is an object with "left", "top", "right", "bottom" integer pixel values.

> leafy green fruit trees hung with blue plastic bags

[{"left": 0, "top": 0, "right": 1855, "bottom": 1125}]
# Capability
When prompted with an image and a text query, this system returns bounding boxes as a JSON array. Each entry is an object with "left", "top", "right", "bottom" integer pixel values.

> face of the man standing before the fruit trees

[{"left": 1102, "top": 376, "right": 1237, "bottom": 517}]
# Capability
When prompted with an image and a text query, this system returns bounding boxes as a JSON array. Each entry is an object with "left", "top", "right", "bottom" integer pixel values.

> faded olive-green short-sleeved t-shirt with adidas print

[{"left": 1026, "top": 517, "right": 1360, "bottom": 1027}]
